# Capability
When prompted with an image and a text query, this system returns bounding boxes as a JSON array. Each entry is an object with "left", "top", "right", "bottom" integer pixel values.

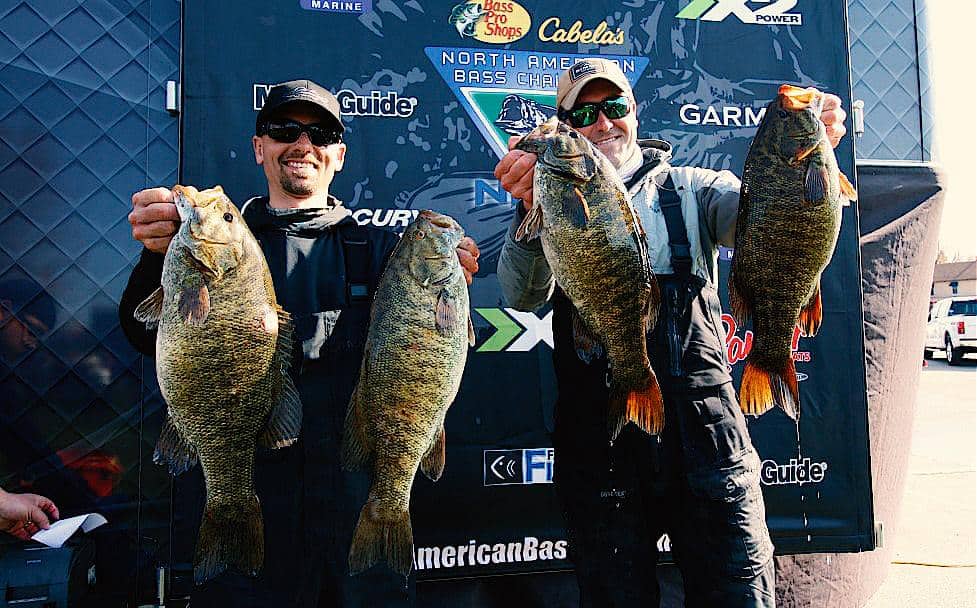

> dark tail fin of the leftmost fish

[{"left": 193, "top": 495, "right": 265, "bottom": 585}]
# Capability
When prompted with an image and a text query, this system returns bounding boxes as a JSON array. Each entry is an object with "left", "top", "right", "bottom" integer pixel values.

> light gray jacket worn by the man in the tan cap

[{"left": 498, "top": 139, "right": 740, "bottom": 311}]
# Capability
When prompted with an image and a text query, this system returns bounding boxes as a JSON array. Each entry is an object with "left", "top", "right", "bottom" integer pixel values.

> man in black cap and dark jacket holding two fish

[{"left": 119, "top": 80, "right": 478, "bottom": 608}]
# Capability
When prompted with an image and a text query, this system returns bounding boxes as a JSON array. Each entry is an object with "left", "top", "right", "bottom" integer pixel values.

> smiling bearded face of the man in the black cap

[{"left": 253, "top": 103, "right": 346, "bottom": 207}]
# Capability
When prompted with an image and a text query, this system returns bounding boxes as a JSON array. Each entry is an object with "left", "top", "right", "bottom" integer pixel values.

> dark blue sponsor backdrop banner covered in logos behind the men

[{"left": 187, "top": 0, "right": 873, "bottom": 578}]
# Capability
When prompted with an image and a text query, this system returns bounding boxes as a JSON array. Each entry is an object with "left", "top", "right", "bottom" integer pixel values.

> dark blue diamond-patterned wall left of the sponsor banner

[{"left": 0, "top": 0, "right": 181, "bottom": 605}]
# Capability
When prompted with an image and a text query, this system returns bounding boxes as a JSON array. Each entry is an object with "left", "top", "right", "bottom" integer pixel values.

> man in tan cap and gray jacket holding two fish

[{"left": 495, "top": 59, "right": 845, "bottom": 608}]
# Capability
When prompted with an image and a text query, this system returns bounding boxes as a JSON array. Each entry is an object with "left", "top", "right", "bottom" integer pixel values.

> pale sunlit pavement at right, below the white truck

[{"left": 864, "top": 354, "right": 977, "bottom": 608}]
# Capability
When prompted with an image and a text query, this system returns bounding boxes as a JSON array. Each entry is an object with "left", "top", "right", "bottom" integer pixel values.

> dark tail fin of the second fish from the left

[{"left": 349, "top": 502, "right": 414, "bottom": 576}]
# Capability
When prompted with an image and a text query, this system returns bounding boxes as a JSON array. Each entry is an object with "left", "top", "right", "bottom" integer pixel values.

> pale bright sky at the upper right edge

[{"left": 926, "top": 0, "right": 977, "bottom": 260}]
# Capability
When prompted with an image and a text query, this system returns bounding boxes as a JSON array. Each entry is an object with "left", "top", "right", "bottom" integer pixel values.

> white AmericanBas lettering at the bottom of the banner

[{"left": 414, "top": 536, "right": 567, "bottom": 570}]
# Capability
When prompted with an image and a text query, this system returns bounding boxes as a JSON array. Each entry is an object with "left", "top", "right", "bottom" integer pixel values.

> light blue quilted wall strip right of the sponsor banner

[{"left": 848, "top": 0, "right": 933, "bottom": 161}]
